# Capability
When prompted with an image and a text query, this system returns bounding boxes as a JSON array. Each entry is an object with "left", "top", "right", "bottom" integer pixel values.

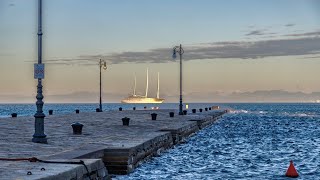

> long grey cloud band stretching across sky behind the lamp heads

[{"left": 44, "top": 31, "right": 320, "bottom": 65}]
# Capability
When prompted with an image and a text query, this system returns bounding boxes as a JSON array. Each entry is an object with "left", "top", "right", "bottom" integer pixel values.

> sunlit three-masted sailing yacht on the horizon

[{"left": 121, "top": 69, "right": 164, "bottom": 103}]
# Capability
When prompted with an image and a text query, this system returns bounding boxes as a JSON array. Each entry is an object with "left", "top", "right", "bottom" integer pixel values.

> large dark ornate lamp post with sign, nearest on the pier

[{"left": 32, "top": 0, "right": 48, "bottom": 143}]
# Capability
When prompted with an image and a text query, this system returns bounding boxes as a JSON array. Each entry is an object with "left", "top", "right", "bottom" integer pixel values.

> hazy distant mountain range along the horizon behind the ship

[{"left": 0, "top": 90, "right": 320, "bottom": 103}]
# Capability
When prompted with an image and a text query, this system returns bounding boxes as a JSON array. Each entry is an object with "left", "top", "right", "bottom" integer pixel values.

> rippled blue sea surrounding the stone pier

[{"left": 0, "top": 103, "right": 320, "bottom": 180}]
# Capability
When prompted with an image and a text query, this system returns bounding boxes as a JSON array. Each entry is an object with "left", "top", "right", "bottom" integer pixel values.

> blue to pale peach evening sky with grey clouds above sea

[{"left": 0, "top": 0, "right": 320, "bottom": 103}]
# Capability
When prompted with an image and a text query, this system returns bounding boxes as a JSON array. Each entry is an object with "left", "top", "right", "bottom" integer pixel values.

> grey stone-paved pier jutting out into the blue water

[{"left": 0, "top": 110, "right": 226, "bottom": 179}]
